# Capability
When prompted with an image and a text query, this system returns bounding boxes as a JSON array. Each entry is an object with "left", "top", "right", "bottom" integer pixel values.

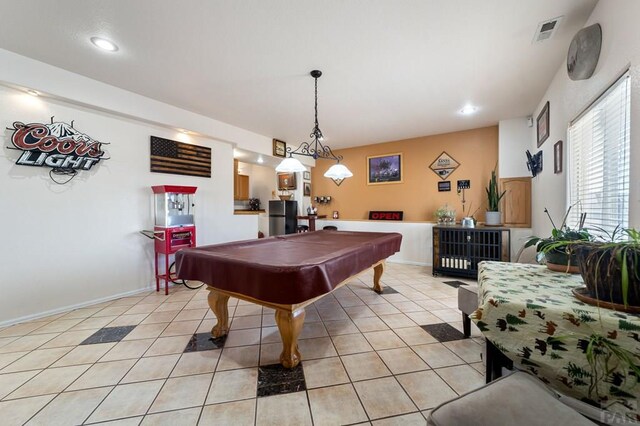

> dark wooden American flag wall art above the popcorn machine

[{"left": 151, "top": 136, "right": 211, "bottom": 178}]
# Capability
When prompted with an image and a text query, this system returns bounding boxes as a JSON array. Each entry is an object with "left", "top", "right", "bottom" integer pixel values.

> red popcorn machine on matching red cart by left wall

[{"left": 151, "top": 185, "right": 198, "bottom": 294}]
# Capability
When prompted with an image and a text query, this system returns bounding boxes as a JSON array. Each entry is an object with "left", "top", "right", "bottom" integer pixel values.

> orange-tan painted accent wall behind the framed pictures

[{"left": 311, "top": 126, "right": 498, "bottom": 222}]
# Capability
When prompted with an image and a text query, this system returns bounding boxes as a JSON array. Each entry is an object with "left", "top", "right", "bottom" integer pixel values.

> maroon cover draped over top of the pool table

[{"left": 176, "top": 231, "right": 402, "bottom": 305}]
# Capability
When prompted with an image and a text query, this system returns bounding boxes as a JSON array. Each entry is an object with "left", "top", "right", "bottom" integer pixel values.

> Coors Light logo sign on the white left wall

[{"left": 8, "top": 117, "right": 108, "bottom": 184}]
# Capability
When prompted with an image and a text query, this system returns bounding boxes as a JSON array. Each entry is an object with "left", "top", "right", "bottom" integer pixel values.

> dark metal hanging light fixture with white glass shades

[{"left": 276, "top": 70, "right": 353, "bottom": 186}]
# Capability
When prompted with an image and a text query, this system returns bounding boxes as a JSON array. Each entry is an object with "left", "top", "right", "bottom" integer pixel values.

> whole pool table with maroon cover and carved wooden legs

[{"left": 176, "top": 231, "right": 402, "bottom": 368}]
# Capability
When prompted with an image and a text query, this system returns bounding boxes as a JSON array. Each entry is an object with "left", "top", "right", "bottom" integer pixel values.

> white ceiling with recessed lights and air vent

[{"left": 0, "top": 0, "right": 597, "bottom": 149}]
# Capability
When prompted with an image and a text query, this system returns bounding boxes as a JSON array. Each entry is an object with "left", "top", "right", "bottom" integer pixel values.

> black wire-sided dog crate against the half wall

[{"left": 433, "top": 226, "right": 511, "bottom": 278}]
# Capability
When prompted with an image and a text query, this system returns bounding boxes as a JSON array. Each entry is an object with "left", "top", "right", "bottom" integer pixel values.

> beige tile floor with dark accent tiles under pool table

[{"left": 0, "top": 263, "right": 484, "bottom": 425}]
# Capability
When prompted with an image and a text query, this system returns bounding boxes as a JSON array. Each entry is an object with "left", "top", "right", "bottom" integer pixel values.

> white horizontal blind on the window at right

[{"left": 567, "top": 71, "right": 631, "bottom": 234}]
